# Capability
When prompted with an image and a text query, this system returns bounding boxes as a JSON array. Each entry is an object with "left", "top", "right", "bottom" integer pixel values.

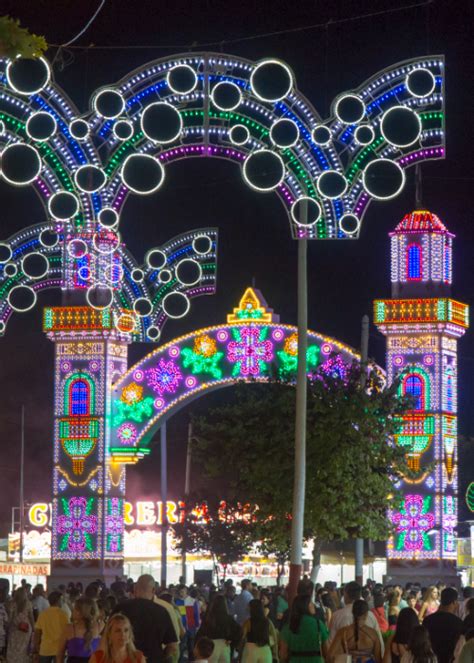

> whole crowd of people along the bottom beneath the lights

[{"left": 0, "top": 575, "right": 474, "bottom": 663}]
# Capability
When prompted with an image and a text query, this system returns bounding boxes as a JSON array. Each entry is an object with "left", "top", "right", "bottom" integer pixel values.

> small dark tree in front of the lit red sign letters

[{"left": 172, "top": 496, "right": 255, "bottom": 580}]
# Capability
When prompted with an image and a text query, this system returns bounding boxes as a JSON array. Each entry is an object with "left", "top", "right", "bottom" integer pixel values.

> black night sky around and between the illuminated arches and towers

[{"left": 0, "top": 0, "right": 474, "bottom": 535}]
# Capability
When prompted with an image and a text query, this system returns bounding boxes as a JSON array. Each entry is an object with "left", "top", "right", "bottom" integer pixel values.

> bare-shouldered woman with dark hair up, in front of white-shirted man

[{"left": 328, "top": 599, "right": 382, "bottom": 663}]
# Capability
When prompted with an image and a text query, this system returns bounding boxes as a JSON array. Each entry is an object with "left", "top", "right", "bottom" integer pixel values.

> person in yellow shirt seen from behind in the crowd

[{"left": 33, "top": 590, "right": 68, "bottom": 663}]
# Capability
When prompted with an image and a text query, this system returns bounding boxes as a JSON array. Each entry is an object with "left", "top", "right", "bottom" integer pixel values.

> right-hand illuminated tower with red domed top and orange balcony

[{"left": 374, "top": 210, "right": 468, "bottom": 579}]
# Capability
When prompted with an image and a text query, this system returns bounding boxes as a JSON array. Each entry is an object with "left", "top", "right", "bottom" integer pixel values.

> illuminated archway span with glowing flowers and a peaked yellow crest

[{"left": 110, "top": 288, "right": 374, "bottom": 463}]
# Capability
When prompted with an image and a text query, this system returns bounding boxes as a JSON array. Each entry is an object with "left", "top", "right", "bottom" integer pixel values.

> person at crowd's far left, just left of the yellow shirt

[{"left": 7, "top": 585, "right": 34, "bottom": 663}]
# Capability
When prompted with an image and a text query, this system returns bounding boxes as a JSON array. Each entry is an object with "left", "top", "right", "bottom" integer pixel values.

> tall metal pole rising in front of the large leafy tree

[{"left": 288, "top": 235, "right": 308, "bottom": 601}]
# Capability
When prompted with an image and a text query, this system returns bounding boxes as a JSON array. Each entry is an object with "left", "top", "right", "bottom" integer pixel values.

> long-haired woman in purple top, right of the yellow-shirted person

[{"left": 56, "top": 597, "right": 100, "bottom": 663}]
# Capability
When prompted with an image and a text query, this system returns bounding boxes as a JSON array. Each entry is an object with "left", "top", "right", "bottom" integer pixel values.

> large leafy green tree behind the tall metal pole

[{"left": 194, "top": 357, "right": 410, "bottom": 580}]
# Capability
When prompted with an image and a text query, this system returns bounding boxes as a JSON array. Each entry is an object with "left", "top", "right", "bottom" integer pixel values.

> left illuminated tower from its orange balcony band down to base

[{"left": 43, "top": 306, "right": 134, "bottom": 583}]
